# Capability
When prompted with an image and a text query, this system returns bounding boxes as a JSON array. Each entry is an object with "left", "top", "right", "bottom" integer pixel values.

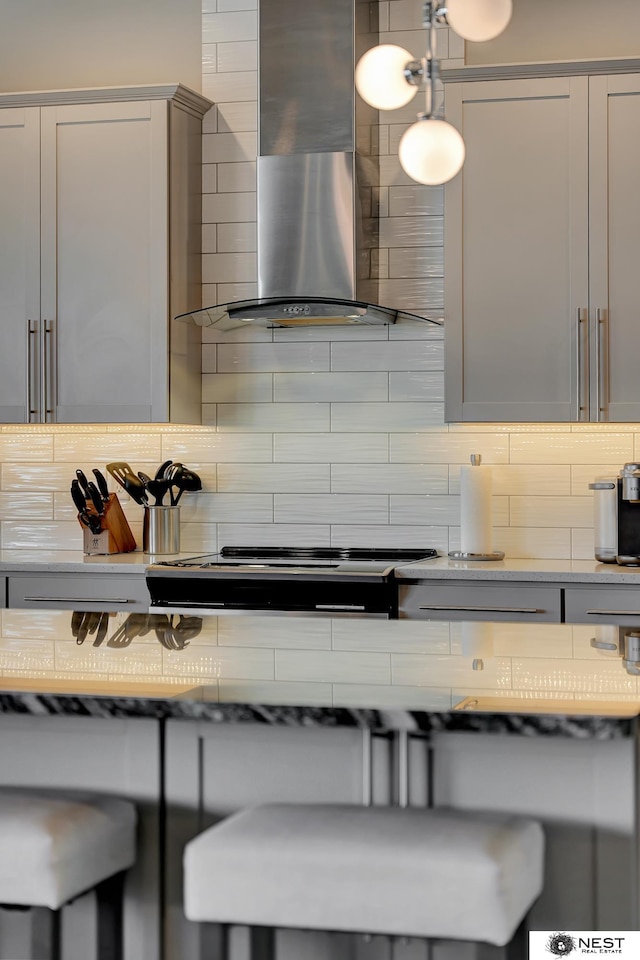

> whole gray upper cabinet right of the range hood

[{"left": 445, "top": 74, "right": 640, "bottom": 422}]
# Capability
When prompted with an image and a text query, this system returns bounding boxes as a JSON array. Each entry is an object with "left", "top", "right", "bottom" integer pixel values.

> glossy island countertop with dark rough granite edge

[{"left": 0, "top": 610, "right": 640, "bottom": 737}]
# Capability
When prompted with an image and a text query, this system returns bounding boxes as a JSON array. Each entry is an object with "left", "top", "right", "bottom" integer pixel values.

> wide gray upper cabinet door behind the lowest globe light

[{"left": 445, "top": 77, "right": 589, "bottom": 421}]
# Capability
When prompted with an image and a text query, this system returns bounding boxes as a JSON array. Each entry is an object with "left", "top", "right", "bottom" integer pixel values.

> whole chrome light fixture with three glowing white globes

[{"left": 355, "top": 0, "right": 513, "bottom": 186}]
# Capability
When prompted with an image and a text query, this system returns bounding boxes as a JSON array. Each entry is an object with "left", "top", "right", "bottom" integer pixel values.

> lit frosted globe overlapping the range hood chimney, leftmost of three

[{"left": 356, "top": 43, "right": 418, "bottom": 110}]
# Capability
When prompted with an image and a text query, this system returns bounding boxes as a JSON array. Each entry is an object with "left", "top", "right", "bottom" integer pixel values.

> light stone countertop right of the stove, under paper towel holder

[{"left": 395, "top": 557, "right": 640, "bottom": 586}]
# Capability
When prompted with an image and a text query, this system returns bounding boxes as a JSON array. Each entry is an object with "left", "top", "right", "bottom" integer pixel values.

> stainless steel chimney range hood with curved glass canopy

[{"left": 178, "top": 0, "right": 442, "bottom": 330}]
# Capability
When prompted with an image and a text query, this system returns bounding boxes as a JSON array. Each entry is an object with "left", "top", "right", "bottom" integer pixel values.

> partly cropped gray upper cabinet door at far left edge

[{"left": 0, "top": 107, "right": 40, "bottom": 423}]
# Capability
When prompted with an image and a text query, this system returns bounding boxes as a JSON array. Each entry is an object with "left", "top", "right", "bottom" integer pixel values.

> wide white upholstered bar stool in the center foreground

[{"left": 184, "top": 804, "right": 544, "bottom": 960}]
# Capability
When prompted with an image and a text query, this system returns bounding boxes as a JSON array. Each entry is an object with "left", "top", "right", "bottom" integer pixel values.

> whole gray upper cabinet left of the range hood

[{"left": 0, "top": 85, "right": 210, "bottom": 423}]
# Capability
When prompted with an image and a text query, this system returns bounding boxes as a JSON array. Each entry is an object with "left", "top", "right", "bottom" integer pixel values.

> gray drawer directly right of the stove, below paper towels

[{"left": 399, "top": 581, "right": 562, "bottom": 623}]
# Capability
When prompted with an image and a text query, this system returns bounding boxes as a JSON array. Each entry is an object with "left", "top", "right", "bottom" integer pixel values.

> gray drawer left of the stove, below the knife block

[{"left": 7, "top": 573, "right": 149, "bottom": 612}]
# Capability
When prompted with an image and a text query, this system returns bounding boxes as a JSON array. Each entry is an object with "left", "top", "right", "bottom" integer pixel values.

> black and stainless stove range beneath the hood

[{"left": 146, "top": 547, "right": 437, "bottom": 618}]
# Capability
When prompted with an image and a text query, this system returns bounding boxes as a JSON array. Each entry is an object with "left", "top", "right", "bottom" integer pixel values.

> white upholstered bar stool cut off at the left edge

[{"left": 0, "top": 788, "right": 136, "bottom": 960}]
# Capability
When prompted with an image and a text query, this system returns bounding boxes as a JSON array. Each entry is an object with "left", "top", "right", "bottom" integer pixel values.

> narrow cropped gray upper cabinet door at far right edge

[{"left": 589, "top": 75, "right": 640, "bottom": 422}]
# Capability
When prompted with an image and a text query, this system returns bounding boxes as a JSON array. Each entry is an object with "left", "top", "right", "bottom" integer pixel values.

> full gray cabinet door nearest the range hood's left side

[{"left": 41, "top": 101, "right": 168, "bottom": 423}]
